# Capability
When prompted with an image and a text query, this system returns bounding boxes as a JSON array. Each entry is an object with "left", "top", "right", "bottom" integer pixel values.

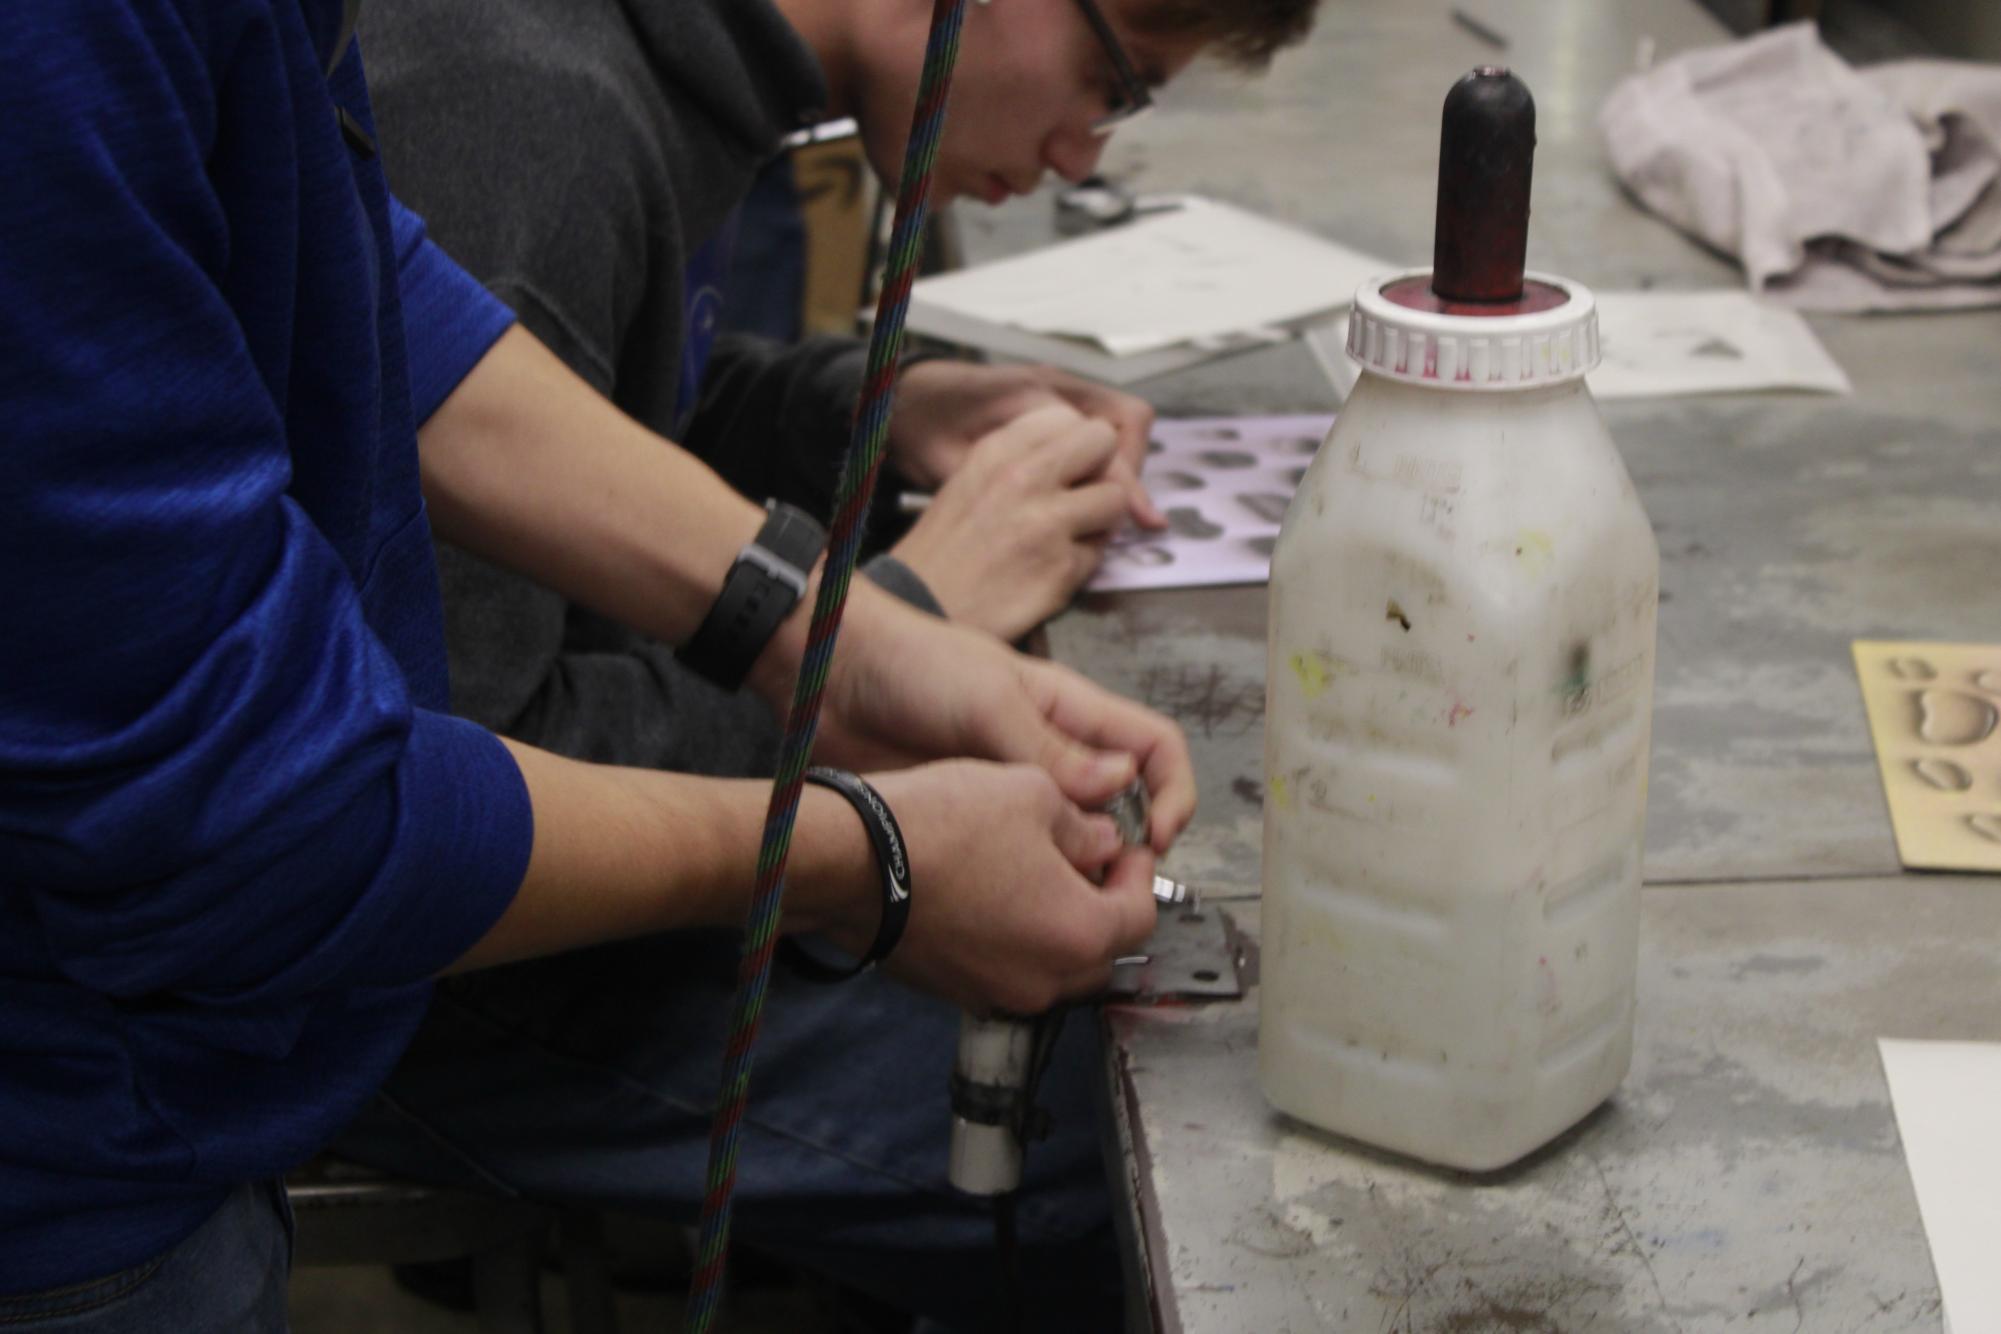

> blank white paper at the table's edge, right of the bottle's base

[{"left": 1877, "top": 1038, "right": 2001, "bottom": 1334}]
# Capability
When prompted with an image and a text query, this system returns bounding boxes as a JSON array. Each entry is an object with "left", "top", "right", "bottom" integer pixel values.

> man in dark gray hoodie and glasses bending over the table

[{"left": 344, "top": 0, "right": 1315, "bottom": 1330}]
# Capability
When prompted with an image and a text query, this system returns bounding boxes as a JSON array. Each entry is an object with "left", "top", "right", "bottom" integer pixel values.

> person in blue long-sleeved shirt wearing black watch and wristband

[{"left": 0, "top": 0, "right": 1195, "bottom": 1334}]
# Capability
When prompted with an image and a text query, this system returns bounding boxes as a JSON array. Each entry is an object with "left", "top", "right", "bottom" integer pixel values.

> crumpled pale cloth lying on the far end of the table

[{"left": 1599, "top": 24, "right": 2001, "bottom": 310}]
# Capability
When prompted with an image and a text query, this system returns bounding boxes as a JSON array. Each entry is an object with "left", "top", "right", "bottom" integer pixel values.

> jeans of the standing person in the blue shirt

[{"left": 0, "top": 1182, "right": 292, "bottom": 1334}]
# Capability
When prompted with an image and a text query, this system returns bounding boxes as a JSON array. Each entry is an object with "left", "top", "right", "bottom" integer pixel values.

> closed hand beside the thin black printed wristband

[{"left": 858, "top": 760, "right": 1157, "bottom": 1014}]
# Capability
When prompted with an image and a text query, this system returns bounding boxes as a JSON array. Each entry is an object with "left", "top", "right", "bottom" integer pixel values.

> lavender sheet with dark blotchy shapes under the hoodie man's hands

[{"left": 1091, "top": 416, "right": 1335, "bottom": 592}]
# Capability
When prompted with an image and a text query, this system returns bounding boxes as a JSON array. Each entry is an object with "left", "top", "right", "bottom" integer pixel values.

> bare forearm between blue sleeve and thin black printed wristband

[{"left": 448, "top": 742, "right": 874, "bottom": 972}]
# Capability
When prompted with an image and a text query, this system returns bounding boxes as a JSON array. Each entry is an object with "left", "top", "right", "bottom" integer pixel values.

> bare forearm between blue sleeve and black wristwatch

[{"left": 418, "top": 328, "right": 762, "bottom": 644}]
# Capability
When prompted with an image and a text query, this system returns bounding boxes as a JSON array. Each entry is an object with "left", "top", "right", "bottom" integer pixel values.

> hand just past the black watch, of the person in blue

[{"left": 750, "top": 580, "right": 1195, "bottom": 854}]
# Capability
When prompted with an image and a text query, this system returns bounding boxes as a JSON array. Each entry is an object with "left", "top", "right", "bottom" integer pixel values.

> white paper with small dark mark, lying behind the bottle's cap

[{"left": 1307, "top": 290, "right": 1853, "bottom": 400}]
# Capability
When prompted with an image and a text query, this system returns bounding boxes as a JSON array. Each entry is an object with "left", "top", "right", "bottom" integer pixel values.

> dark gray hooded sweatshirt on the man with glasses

[{"left": 360, "top": 0, "right": 936, "bottom": 774}]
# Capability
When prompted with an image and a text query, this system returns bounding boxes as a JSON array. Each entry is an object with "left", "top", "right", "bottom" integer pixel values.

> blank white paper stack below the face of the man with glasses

[{"left": 910, "top": 196, "right": 1395, "bottom": 356}]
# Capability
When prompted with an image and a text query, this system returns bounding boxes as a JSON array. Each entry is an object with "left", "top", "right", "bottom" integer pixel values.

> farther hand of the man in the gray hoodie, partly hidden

[{"left": 888, "top": 362, "right": 1167, "bottom": 528}]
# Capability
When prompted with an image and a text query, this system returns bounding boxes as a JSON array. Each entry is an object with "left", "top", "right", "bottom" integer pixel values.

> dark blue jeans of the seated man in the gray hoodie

[{"left": 334, "top": 932, "right": 1121, "bottom": 1334}]
